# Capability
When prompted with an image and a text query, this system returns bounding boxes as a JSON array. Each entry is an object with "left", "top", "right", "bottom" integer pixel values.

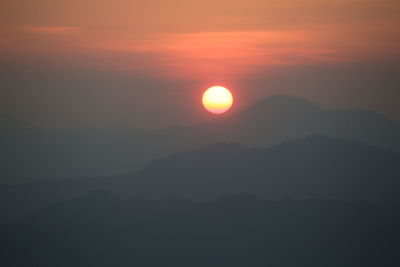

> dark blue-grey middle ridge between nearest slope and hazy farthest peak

[{"left": 0, "top": 136, "right": 400, "bottom": 222}]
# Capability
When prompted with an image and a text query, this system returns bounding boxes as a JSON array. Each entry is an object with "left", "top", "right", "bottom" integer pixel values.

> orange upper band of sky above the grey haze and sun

[{"left": 0, "top": 0, "right": 400, "bottom": 81}]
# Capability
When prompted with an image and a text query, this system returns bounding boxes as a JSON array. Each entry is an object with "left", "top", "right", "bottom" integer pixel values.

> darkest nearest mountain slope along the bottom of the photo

[{"left": 0, "top": 192, "right": 400, "bottom": 267}]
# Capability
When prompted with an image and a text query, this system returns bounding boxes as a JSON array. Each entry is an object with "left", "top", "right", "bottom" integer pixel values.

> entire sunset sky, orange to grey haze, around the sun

[{"left": 0, "top": 0, "right": 400, "bottom": 128}]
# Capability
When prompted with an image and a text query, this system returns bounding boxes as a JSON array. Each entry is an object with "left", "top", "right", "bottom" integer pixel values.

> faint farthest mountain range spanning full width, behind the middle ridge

[{"left": 0, "top": 95, "right": 400, "bottom": 183}]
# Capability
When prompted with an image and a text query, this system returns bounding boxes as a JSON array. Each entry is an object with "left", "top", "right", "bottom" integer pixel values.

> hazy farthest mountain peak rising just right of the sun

[{"left": 191, "top": 95, "right": 400, "bottom": 151}]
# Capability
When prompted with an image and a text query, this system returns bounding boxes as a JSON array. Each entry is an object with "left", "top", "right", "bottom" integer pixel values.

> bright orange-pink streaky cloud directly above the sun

[{"left": 84, "top": 31, "right": 366, "bottom": 79}]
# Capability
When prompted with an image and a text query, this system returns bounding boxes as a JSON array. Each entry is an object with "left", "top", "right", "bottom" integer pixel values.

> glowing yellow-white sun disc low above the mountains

[{"left": 202, "top": 86, "right": 233, "bottom": 114}]
